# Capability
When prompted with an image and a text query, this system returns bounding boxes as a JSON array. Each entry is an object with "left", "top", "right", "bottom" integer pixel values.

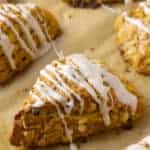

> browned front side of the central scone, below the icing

[{"left": 10, "top": 100, "right": 142, "bottom": 147}]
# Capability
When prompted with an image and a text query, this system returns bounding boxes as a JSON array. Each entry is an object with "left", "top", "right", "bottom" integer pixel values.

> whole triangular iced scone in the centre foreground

[{"left": 11, "top": 54, "right": 142, "bottom": 146}]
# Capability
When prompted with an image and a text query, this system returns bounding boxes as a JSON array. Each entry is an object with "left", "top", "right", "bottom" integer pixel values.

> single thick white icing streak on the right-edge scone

[{"left": 123, "top": 12, "right": 150, "bottom": 34}]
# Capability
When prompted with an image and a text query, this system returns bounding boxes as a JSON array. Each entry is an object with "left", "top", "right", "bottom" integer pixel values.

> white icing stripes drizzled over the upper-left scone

[{"left": 0, "top": 4, "right": 54, "bottom": 70}]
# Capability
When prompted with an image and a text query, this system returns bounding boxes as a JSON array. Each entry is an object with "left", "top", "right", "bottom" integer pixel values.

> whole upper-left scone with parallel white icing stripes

[{"left": 0, "top": 4, "right": 60, "bottom": 83}]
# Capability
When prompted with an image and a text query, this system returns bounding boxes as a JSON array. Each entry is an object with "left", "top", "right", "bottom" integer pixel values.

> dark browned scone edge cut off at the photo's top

[{"left": 63, "top": 0, "right": 142, "bottom": 8}]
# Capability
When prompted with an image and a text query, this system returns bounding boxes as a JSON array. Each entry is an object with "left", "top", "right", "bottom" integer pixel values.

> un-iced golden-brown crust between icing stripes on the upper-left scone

[{"left": 0, "top": 4, "right": 61, "bottom": 84}]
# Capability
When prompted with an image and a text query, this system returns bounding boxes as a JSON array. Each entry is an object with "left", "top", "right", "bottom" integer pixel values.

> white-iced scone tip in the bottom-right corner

[{"left": 125, "top": 136, "right": 150, "bottom": 150}]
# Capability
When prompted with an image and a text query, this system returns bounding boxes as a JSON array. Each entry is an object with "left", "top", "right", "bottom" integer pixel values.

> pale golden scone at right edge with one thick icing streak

[{"left": 115, "top": 1, "right": 150, "bottom": 75}]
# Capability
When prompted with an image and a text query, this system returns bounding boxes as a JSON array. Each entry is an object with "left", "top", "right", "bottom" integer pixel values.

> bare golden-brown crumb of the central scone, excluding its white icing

[{"left": 10, "top": 54, "right": 143, "bottom": 147}]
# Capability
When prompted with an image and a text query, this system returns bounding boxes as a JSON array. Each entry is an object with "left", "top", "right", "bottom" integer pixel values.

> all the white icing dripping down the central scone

[{"left": 30, "top": 54, "right": 137, "bottom": 150}]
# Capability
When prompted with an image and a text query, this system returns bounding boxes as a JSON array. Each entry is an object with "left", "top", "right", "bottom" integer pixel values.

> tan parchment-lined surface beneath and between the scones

[{"left": 0, "top": 0, "right": 150, "bottom": 150}]
